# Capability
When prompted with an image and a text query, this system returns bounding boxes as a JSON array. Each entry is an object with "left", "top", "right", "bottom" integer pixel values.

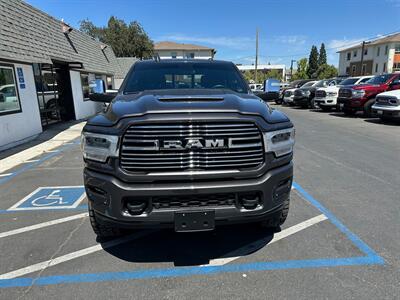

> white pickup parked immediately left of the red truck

[{"left": 314, "top": 76, "right": 372, "bottom": 111}]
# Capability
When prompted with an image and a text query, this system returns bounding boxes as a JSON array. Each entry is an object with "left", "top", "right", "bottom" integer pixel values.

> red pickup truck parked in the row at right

[{"left": 338, "top": 73, "right": 400, "bottom": 117}]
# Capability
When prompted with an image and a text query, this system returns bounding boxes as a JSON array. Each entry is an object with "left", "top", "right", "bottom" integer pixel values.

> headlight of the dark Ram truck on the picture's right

[{"left": 264, "top": 127, "right": 296, "bottom": 157}]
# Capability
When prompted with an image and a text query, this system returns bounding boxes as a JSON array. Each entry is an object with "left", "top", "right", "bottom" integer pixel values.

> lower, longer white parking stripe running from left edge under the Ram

[{"left": 0, "top": 231, "right": 154, "bottom": 279}]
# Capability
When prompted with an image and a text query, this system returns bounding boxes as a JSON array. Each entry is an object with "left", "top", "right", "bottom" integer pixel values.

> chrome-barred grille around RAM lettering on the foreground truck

[{"left": 120, "top": 121, "right": 264, "bottom": 172}]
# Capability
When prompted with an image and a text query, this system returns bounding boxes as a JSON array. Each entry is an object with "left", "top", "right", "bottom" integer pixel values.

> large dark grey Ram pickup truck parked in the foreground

[{"left": 82, "top": 59, "right": 295, "bottom": 238}]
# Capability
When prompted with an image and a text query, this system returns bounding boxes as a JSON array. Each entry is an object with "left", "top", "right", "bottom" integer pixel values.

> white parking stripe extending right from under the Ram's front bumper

[{"left": 202, "top": 214, "right": 328, "bottom": 267}]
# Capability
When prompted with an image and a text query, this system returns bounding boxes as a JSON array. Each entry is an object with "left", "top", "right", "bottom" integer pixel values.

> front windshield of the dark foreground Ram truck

[{"left": 123, "top": 61, "right": 248, "bottom": 94}]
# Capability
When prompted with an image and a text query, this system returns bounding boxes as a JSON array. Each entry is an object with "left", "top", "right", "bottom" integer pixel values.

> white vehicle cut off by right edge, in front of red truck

[{"left": 372, "top": 90, "right": 400, "bottom": 121}]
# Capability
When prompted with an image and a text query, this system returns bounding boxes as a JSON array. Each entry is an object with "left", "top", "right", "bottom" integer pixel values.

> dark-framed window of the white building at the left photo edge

[{"left": 0, "top": 65, "right": 21, "bottom": 115}]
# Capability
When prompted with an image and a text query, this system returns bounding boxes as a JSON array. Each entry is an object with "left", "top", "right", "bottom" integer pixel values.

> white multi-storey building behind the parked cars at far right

[{"left": 338, "top": 33, "right": 400, "bottom": 76}]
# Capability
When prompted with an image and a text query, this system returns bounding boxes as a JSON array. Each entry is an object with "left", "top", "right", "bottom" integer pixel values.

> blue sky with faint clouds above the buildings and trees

[{"left": 27, "top": 0, "right": 400, "bottom": 67}]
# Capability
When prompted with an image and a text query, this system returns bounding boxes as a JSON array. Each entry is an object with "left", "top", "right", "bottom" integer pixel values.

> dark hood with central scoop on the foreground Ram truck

[{"left": 88, "top": 89, "right": 289, "bottom": 126}]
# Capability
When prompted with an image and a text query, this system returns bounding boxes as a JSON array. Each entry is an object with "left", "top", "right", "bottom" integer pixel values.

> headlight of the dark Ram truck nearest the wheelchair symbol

[{"left": 81, "top": 132, "right": 119, "bottom": 162}]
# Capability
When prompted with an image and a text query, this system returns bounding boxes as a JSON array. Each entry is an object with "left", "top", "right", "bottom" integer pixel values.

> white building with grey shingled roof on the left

[{"left": 0, "top": 0, "right": 122, "bottom": 150}]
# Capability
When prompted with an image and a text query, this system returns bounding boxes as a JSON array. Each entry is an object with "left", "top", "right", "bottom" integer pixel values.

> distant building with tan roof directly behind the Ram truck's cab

[{"left": 154, "top": 42, "right": 217, "bottom": 59}]
